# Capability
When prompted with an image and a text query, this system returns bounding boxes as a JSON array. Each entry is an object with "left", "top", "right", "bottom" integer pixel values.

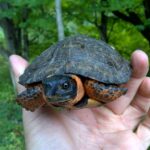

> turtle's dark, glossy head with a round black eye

[{"left": 42, "top": 75, "right": 77, "bottom": 103}]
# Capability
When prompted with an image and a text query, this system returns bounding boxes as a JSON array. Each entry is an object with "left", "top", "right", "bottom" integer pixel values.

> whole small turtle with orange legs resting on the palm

[{"left": 16, "top": 35, "right": 132, "bottom": 111}]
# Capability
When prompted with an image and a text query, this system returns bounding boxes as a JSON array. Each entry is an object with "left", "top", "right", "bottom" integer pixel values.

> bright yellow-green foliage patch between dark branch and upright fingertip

[{"left": 109, "top": 21, "right": 149, "bottom": 59}]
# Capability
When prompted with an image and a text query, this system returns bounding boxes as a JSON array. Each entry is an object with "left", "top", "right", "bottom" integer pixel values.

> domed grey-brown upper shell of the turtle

[{"left": 19, "top": 35, "right": 131, "bottom": 85}]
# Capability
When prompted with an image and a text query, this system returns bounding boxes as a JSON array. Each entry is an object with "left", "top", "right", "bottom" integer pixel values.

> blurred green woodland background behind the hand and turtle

[{"left": 0, "top": 0, "right": 150, "bottom": 150}]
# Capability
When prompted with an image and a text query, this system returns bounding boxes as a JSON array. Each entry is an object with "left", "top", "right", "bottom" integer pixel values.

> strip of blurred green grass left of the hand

[{"left": 0, "top": 57, "right": 24, "bottom": 150}]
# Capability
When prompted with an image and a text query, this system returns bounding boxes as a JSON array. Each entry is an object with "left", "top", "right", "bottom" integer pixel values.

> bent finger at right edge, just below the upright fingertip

[{"left": 131, "top": 77, "right": 150, "bottom": 114}]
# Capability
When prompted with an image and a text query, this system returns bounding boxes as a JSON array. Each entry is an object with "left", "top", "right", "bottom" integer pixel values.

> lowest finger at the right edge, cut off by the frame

[{"left": 136, "top": 110, "right": 150, "bottom": 149}]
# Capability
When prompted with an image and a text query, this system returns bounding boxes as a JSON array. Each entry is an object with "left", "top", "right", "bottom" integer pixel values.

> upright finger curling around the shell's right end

[{"left": 107, "top": 50, "right": 148, "bottom": 114}]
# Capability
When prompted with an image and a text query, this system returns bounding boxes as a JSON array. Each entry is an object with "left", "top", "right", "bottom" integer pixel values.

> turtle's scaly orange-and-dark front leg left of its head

[{"left": 16, "top": 87, "right": 45, "bottom": 111}]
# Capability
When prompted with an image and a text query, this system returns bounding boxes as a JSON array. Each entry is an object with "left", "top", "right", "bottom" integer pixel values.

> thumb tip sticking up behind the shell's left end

[{"left": 9, "top": 55, "right": 28, "bottom": 93}]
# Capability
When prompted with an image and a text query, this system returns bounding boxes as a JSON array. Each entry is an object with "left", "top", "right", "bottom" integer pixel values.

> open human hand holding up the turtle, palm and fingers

[{"left": 10, "top": 50, "right": 150, "bottom": 150}]
